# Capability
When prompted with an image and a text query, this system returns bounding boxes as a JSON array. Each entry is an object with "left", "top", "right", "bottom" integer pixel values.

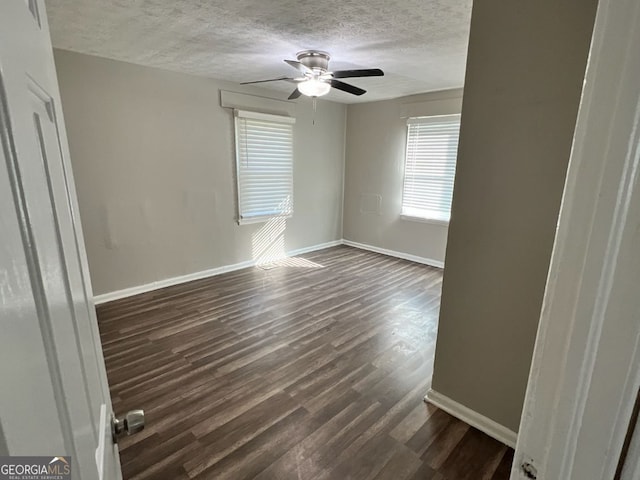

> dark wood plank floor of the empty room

[{"left": 98, "top": 247, "right": 513, "bottom": 480}]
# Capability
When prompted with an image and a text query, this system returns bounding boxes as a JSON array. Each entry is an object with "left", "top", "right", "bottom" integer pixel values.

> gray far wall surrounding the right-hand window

[{"left": 344, "top": 90, "right": 462, "bottom": 263}]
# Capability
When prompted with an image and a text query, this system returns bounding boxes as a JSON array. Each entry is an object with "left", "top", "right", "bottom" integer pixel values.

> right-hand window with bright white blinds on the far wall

[{"left": 402, "top": 115, "right": 460, "bottom": 223}]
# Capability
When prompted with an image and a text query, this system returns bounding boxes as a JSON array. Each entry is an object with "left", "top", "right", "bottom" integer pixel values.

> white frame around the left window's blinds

[{"left": 234, "top": 109, "right": 296, "bottom": 225}]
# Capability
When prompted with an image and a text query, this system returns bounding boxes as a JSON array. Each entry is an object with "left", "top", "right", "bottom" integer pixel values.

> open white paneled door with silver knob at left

[{"left": 0, "top": 0, "right": 121, "bottom": 480}]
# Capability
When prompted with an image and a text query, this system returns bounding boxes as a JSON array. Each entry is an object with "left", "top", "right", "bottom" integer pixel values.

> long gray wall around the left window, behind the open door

[{"left": 55, "top": 50, "right": 346, "bottom": 294}]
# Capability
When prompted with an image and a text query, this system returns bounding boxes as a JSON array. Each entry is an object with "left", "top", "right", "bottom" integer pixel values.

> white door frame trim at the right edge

[{"left": 511, "top": 0, "right": 640, "bottom": 480}]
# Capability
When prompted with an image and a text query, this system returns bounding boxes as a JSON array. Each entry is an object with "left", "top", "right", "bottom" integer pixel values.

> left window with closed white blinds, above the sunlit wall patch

[{"left": 235, "top": 110, "right": 295, "bottom": 224}]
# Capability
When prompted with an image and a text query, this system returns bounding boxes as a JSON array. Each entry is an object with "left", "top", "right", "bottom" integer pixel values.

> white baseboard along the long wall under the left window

[{"left": 93, "top": 240, "right": 342, "bottom": 305}]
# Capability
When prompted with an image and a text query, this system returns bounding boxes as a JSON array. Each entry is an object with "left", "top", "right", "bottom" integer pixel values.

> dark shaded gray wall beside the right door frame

[{"left": 433, "top": 0, "right": 596, "bottom": 431}]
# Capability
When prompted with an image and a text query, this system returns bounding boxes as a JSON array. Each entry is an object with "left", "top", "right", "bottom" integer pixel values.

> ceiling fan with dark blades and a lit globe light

[{"left": 242, "top": 50, "right": 384, "bottom": 100}]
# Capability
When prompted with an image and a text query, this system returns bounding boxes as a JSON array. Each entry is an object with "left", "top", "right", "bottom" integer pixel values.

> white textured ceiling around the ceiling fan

[{"left": 47, "top": 0, "right": 471, "bottom": 103}]
